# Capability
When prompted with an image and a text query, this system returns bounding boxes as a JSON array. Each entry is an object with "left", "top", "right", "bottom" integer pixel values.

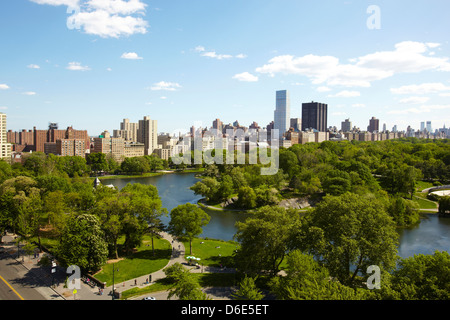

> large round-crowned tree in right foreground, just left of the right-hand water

[{"left": 299, "top": 193, "right": 398, "bottom": 285}]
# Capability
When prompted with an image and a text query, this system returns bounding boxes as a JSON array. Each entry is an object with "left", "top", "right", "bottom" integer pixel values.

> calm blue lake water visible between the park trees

[{"left": 103, "top": 173, "right": 450, "bottom": 258}]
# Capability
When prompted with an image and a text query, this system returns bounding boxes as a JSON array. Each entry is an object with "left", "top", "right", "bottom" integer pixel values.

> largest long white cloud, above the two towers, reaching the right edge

[{"left": 256, "top": 41, "right": 450, "bottom": 87}]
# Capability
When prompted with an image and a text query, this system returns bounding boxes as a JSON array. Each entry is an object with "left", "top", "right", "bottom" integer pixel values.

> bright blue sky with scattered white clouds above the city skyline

[{"left": 0, "top": 0, "right": 450, "bottom": 135}]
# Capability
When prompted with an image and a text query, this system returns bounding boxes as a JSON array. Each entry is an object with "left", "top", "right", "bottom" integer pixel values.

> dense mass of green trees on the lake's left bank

[{"left": 0, "top": 153, "right": 167, "bottom": 271}]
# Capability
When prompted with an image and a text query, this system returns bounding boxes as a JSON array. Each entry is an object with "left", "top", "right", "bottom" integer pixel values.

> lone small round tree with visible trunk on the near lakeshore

[{"left": 169, "top": 203, "right": 211, "bottom": 254}]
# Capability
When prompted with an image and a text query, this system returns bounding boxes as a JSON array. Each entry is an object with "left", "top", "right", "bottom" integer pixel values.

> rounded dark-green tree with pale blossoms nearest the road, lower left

[{"left": 56, "top": 214, "right": 108, "bottom": 271}]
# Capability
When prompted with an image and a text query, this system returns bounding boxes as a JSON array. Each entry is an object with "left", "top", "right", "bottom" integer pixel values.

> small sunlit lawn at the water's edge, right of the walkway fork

[{"left": 183, "top": 238, "right": 239, "bottom": 267}]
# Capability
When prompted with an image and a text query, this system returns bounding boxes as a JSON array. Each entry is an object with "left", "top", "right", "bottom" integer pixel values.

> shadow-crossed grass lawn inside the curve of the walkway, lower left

[{"left": 94, "top": 236, "right": 172, "bottom": 286}]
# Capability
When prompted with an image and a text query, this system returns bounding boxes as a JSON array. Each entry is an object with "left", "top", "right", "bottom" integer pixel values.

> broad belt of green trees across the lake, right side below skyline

[{"left": 191, "top": 138, "right": 450, "bottom": 226}]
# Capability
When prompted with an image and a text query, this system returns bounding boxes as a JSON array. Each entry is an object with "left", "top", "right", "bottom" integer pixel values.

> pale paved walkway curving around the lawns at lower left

[{"left": 2, "top": 232, "right": 234, "bottom": 300}]
